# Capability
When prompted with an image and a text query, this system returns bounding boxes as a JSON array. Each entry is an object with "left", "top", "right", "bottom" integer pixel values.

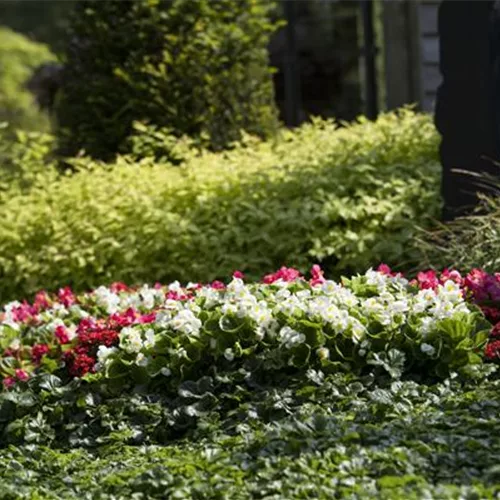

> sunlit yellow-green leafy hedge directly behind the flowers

[{"left": 0, "top": 110, "right": 440, "bottom": 300}]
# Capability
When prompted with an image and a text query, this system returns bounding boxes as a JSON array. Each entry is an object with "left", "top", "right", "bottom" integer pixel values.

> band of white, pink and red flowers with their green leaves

[{"left": 0, "top": 265, "right": 500, "bottom": 393}]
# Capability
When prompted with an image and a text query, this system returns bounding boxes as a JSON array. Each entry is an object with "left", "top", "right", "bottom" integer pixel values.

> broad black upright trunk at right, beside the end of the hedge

[{"left": 436, "top": 0, "right": 500, "bottom": 220}]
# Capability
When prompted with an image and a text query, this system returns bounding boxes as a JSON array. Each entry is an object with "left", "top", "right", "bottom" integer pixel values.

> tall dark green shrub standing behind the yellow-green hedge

[{"left": 58, "top": 0, "right": 277, "bottom": 158}]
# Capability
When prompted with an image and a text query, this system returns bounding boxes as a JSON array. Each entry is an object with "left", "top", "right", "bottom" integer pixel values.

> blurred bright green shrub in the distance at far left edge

[{"left": 0, "top": 27, "right": 55, "bottom": 130}]
